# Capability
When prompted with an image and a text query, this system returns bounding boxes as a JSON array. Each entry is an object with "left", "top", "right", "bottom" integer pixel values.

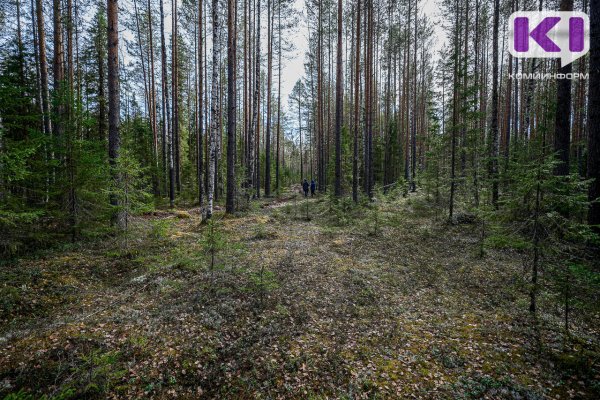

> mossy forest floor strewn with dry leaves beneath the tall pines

[{"left": 0, "top": 193, "right": 600, "bottom": 399}]
